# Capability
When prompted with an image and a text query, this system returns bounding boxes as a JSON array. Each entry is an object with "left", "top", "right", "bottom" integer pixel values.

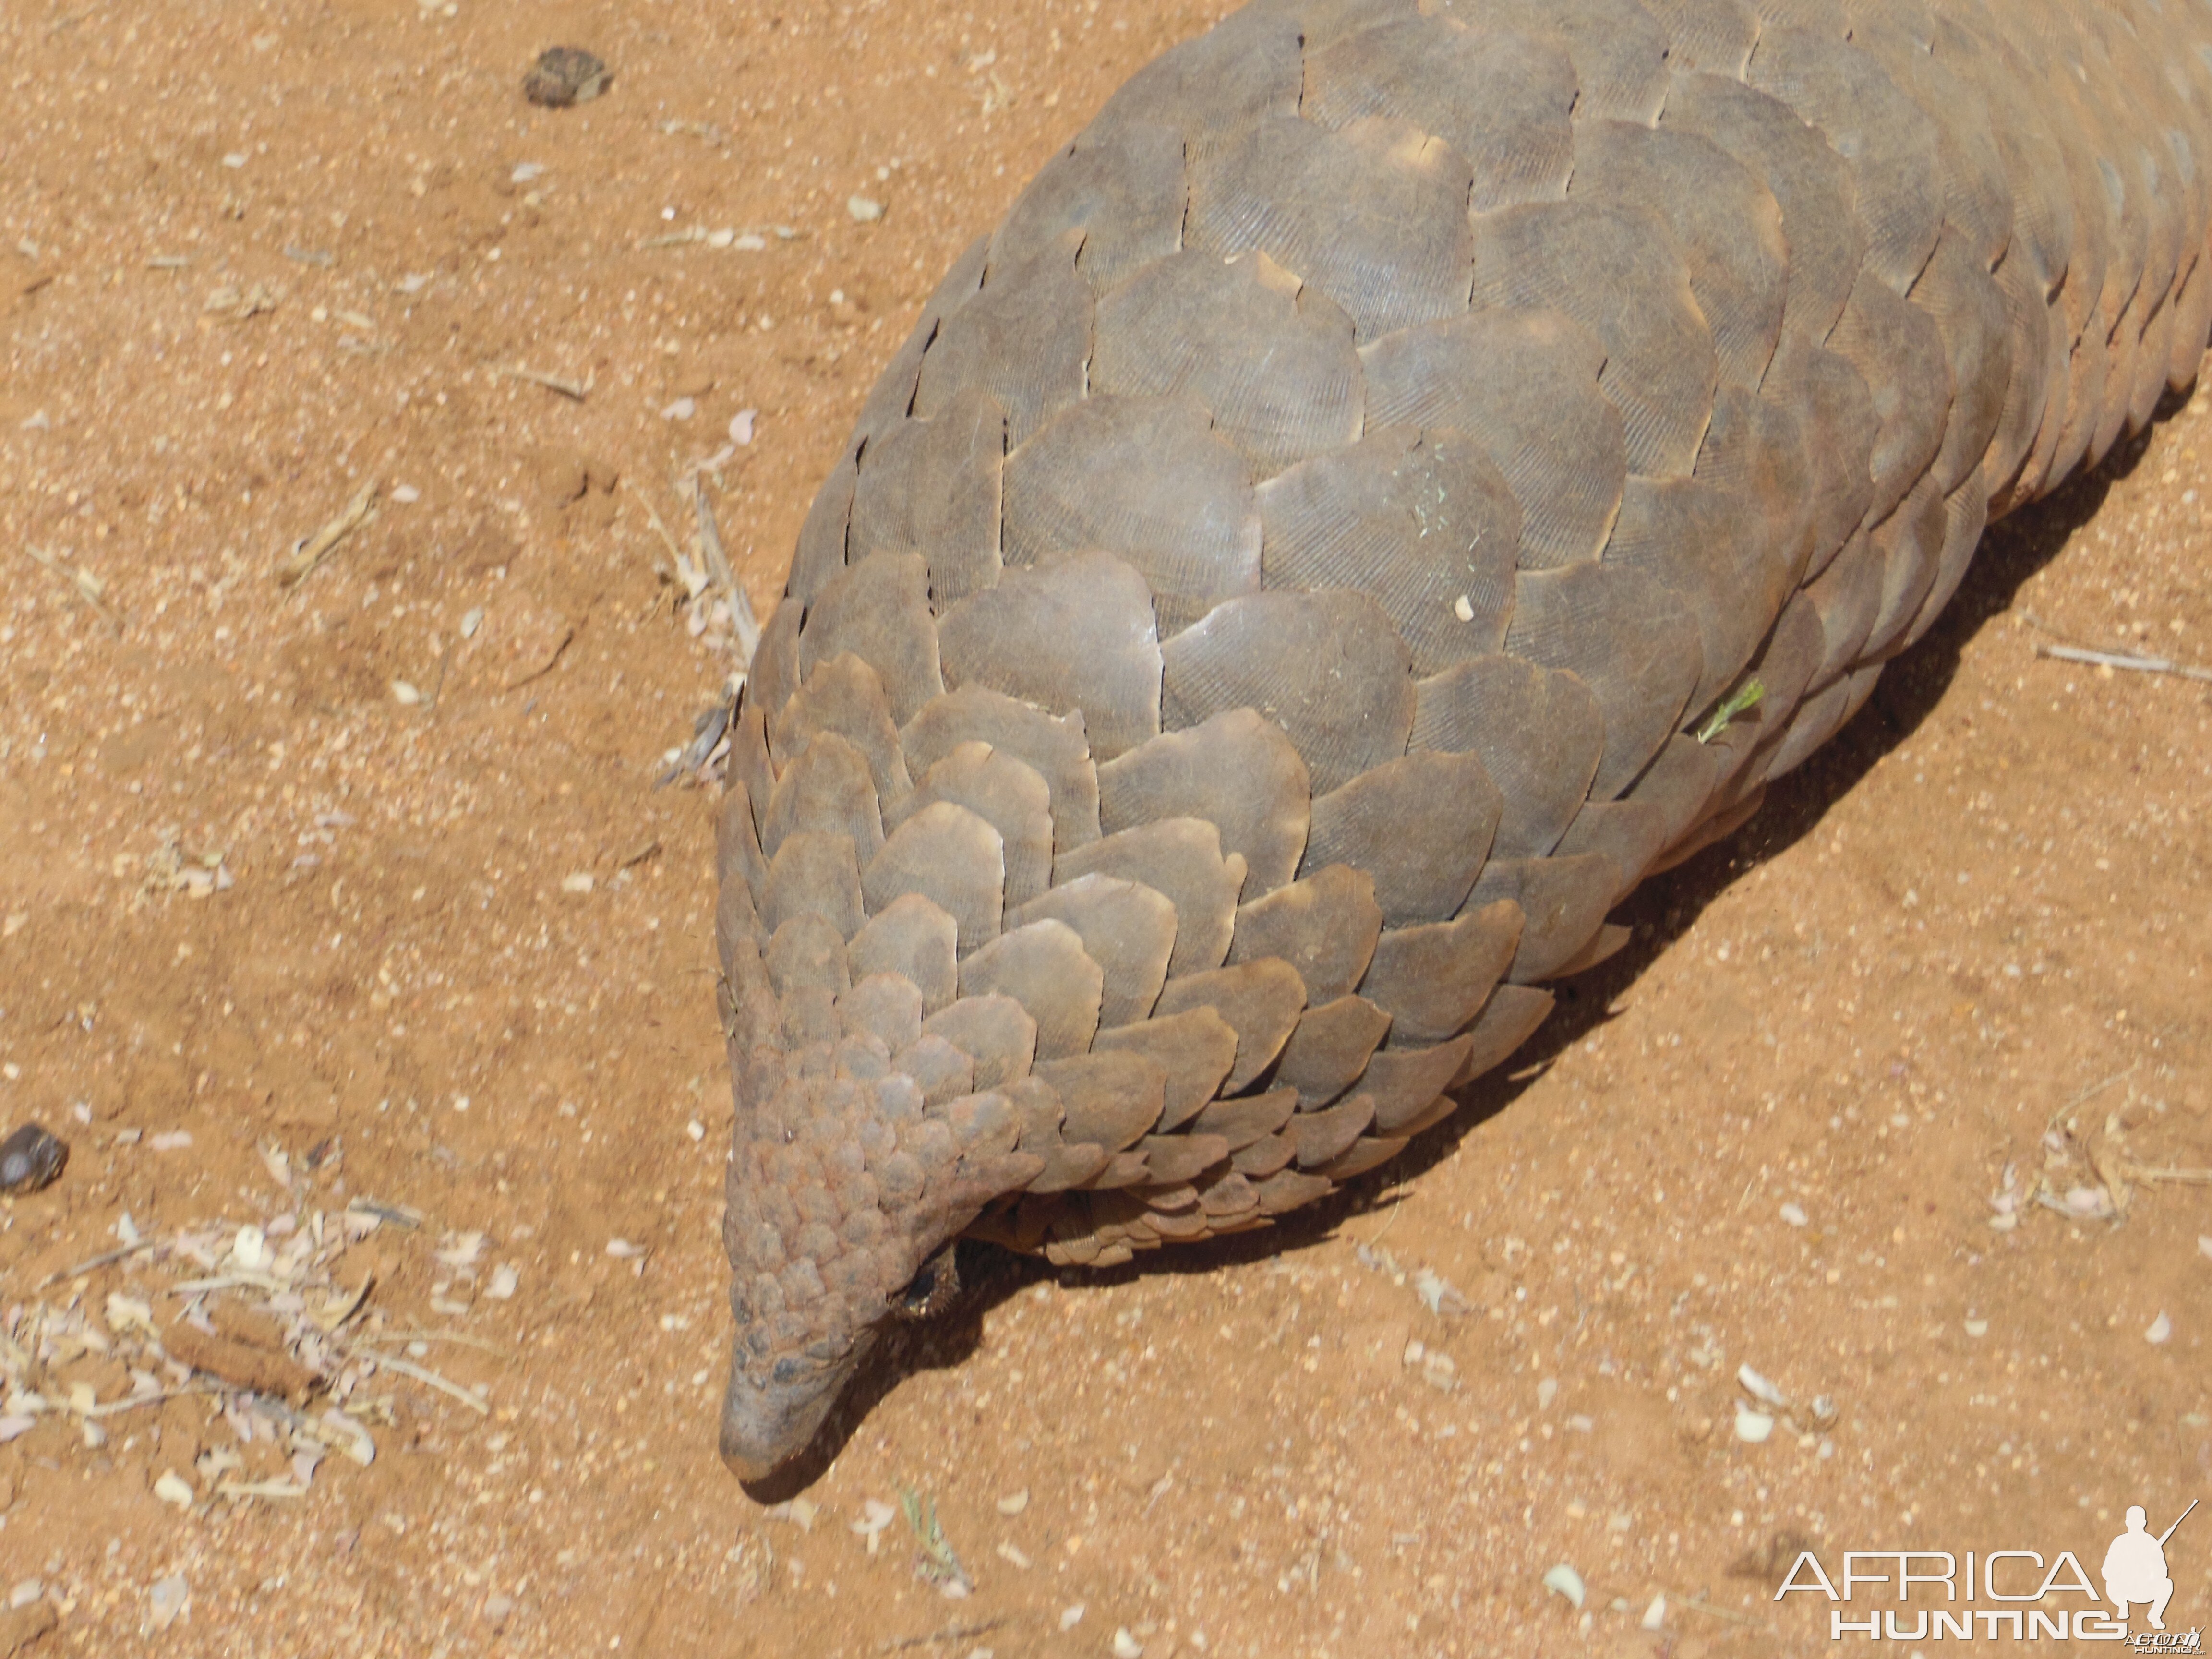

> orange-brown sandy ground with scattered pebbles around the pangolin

[{"left": 0, "top": 0, "right": 2212, "bottom": 1659}]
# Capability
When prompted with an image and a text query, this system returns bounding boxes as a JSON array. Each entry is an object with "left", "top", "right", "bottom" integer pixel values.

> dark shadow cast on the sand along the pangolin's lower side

[{"left": 745, "top": 407, "right": 2159, "bottom": 1504}]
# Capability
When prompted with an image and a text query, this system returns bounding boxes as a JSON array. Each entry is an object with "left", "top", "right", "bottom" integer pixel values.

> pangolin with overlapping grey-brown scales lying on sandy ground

[{"left": 717, "top": 0, "right": 2212, "bottom": 1478}]
